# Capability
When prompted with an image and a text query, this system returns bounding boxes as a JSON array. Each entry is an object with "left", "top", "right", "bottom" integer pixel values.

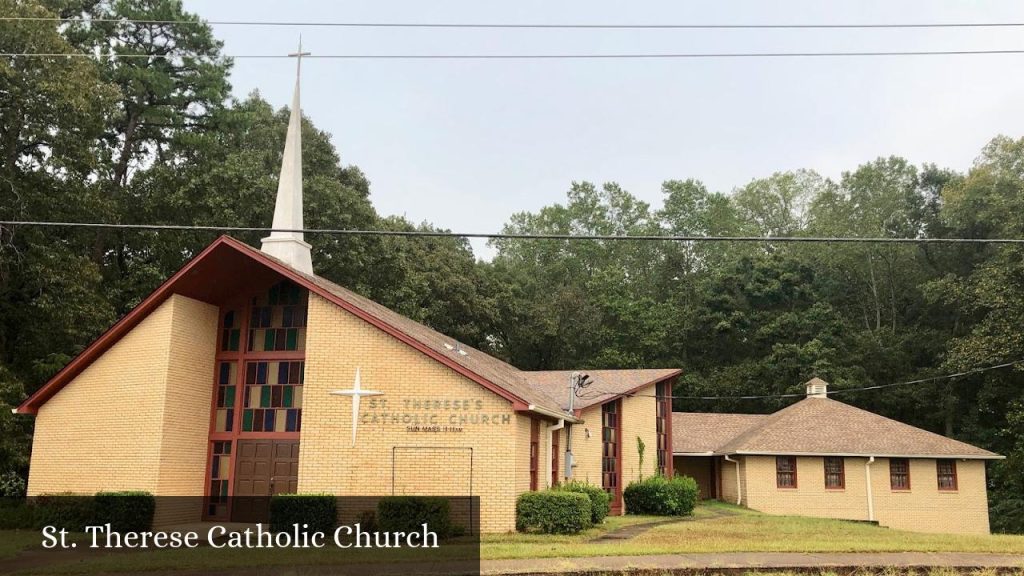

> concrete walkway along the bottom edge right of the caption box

[{"left": 480, "top": 552, "right": 1024, "bottom": 575}]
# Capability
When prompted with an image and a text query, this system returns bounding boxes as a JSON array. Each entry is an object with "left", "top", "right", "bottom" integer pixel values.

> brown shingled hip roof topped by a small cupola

[{"left": 715, "top": 398, "right": 1001, "bottom": 459}]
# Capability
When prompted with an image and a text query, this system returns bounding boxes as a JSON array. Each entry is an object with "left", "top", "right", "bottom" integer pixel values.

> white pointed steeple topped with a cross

[{"left": 262, "top": 39, "right": 313, "bottom": 274}]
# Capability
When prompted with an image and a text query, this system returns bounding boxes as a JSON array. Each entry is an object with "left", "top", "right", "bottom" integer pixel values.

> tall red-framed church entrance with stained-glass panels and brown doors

[{"left": 204, "top": 281, "right": 309, "bottom": 522}]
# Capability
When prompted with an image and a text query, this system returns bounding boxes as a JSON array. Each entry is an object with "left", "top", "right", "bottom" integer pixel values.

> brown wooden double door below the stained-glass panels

[{"left": 231, "top": 440, "right": 299, "bottom": 523}]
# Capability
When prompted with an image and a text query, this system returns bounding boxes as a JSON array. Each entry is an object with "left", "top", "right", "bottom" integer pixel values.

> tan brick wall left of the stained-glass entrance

[{"left": 29, "top": 295, "right": 217, "bottom": 522}]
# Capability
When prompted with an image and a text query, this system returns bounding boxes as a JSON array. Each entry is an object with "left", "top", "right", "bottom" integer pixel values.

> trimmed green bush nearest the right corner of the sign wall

[{"left": 515, "top": 490, "right": 593, "bottom": 534}]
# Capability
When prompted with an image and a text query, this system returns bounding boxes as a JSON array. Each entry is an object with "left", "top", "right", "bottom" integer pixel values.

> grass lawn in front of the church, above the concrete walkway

[{"left": 6, "top": 503, "right": 1024, "bottom": 574}]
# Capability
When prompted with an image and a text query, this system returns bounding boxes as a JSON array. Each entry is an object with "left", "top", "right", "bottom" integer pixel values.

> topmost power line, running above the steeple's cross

[{"left": 0, "top": 16, "right": 1024, "bottom": 30}]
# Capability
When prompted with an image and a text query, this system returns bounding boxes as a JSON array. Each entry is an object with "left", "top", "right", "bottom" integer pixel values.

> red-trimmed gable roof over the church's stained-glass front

[{"left": 14, "top": 236, "right": 675, "bottom": 421}]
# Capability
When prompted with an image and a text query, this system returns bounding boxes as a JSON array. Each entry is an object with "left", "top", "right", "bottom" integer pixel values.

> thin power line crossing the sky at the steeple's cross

[{"left": 6, "top": 49, "right": 1024, "bottom": 60}]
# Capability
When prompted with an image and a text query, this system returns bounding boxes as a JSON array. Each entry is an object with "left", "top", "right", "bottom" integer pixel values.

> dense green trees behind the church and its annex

[{"left": 0, "top": 0, "right": 1024, "bottom": 532}]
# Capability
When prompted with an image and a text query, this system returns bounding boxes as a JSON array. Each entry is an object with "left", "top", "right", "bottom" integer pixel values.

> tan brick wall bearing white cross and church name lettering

[{"left": 299, "top": 295, "right": 520, "bottom": 532}]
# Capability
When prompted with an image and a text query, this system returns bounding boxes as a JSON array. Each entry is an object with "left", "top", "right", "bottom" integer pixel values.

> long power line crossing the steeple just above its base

[{"left": 0, "top": 220, "right": 1024, "bottom": 245}]
